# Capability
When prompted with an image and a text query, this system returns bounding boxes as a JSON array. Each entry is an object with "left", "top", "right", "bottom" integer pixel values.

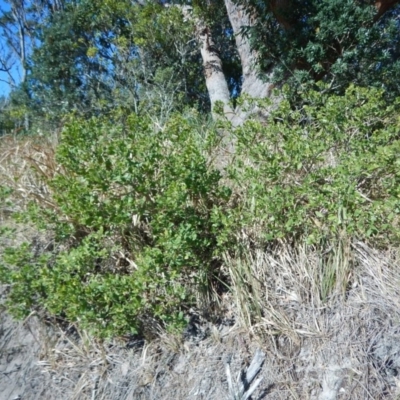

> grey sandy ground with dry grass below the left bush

[{"left": 0, "top": 311, "right": 270, "bottom": 400}]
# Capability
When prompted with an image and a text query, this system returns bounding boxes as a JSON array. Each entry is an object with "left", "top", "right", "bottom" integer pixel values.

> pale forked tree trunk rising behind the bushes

[{"left": 153, "top": 0, "right": 400, "bottom": 126}]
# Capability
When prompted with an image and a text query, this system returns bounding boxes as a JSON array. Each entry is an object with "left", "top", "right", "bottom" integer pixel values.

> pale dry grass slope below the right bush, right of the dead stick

[{"left": 223, "top": 242, "right": 400, "bottom": 400}]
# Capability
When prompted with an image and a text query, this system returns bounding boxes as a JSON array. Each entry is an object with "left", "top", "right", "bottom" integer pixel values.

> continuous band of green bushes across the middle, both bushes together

[{"left": 0, "top": 87, "right": 400, "bottom": 336}]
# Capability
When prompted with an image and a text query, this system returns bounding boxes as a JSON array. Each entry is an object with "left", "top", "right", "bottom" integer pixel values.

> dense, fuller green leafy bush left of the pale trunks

[{"left": 1, "top": 116, "right": 230, "bottom": 335}]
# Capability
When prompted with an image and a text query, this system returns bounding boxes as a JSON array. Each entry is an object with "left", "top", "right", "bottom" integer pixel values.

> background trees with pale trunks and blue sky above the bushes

[{"left": 0, "top": 0, "right": 400, "bottom": 126}]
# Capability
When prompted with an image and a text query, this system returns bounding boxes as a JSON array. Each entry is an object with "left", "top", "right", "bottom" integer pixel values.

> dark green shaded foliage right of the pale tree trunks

[{"left": 248, "top": 0, "right": 400, "bottom": 95}]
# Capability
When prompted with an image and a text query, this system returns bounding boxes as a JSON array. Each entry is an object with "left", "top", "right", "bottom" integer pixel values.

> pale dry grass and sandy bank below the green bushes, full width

[{"left": 0, "top": 239, "right": 400, "bottom": 400}]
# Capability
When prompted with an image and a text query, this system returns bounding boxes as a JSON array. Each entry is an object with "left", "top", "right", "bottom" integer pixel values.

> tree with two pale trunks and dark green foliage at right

[{"left": 181, "top": 0, "right": 400, "bottom": 124}]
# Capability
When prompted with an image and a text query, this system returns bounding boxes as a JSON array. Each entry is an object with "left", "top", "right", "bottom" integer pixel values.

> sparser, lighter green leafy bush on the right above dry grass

[{"left": 230, "top": 87, "right": 400, "bottom": 245}]
